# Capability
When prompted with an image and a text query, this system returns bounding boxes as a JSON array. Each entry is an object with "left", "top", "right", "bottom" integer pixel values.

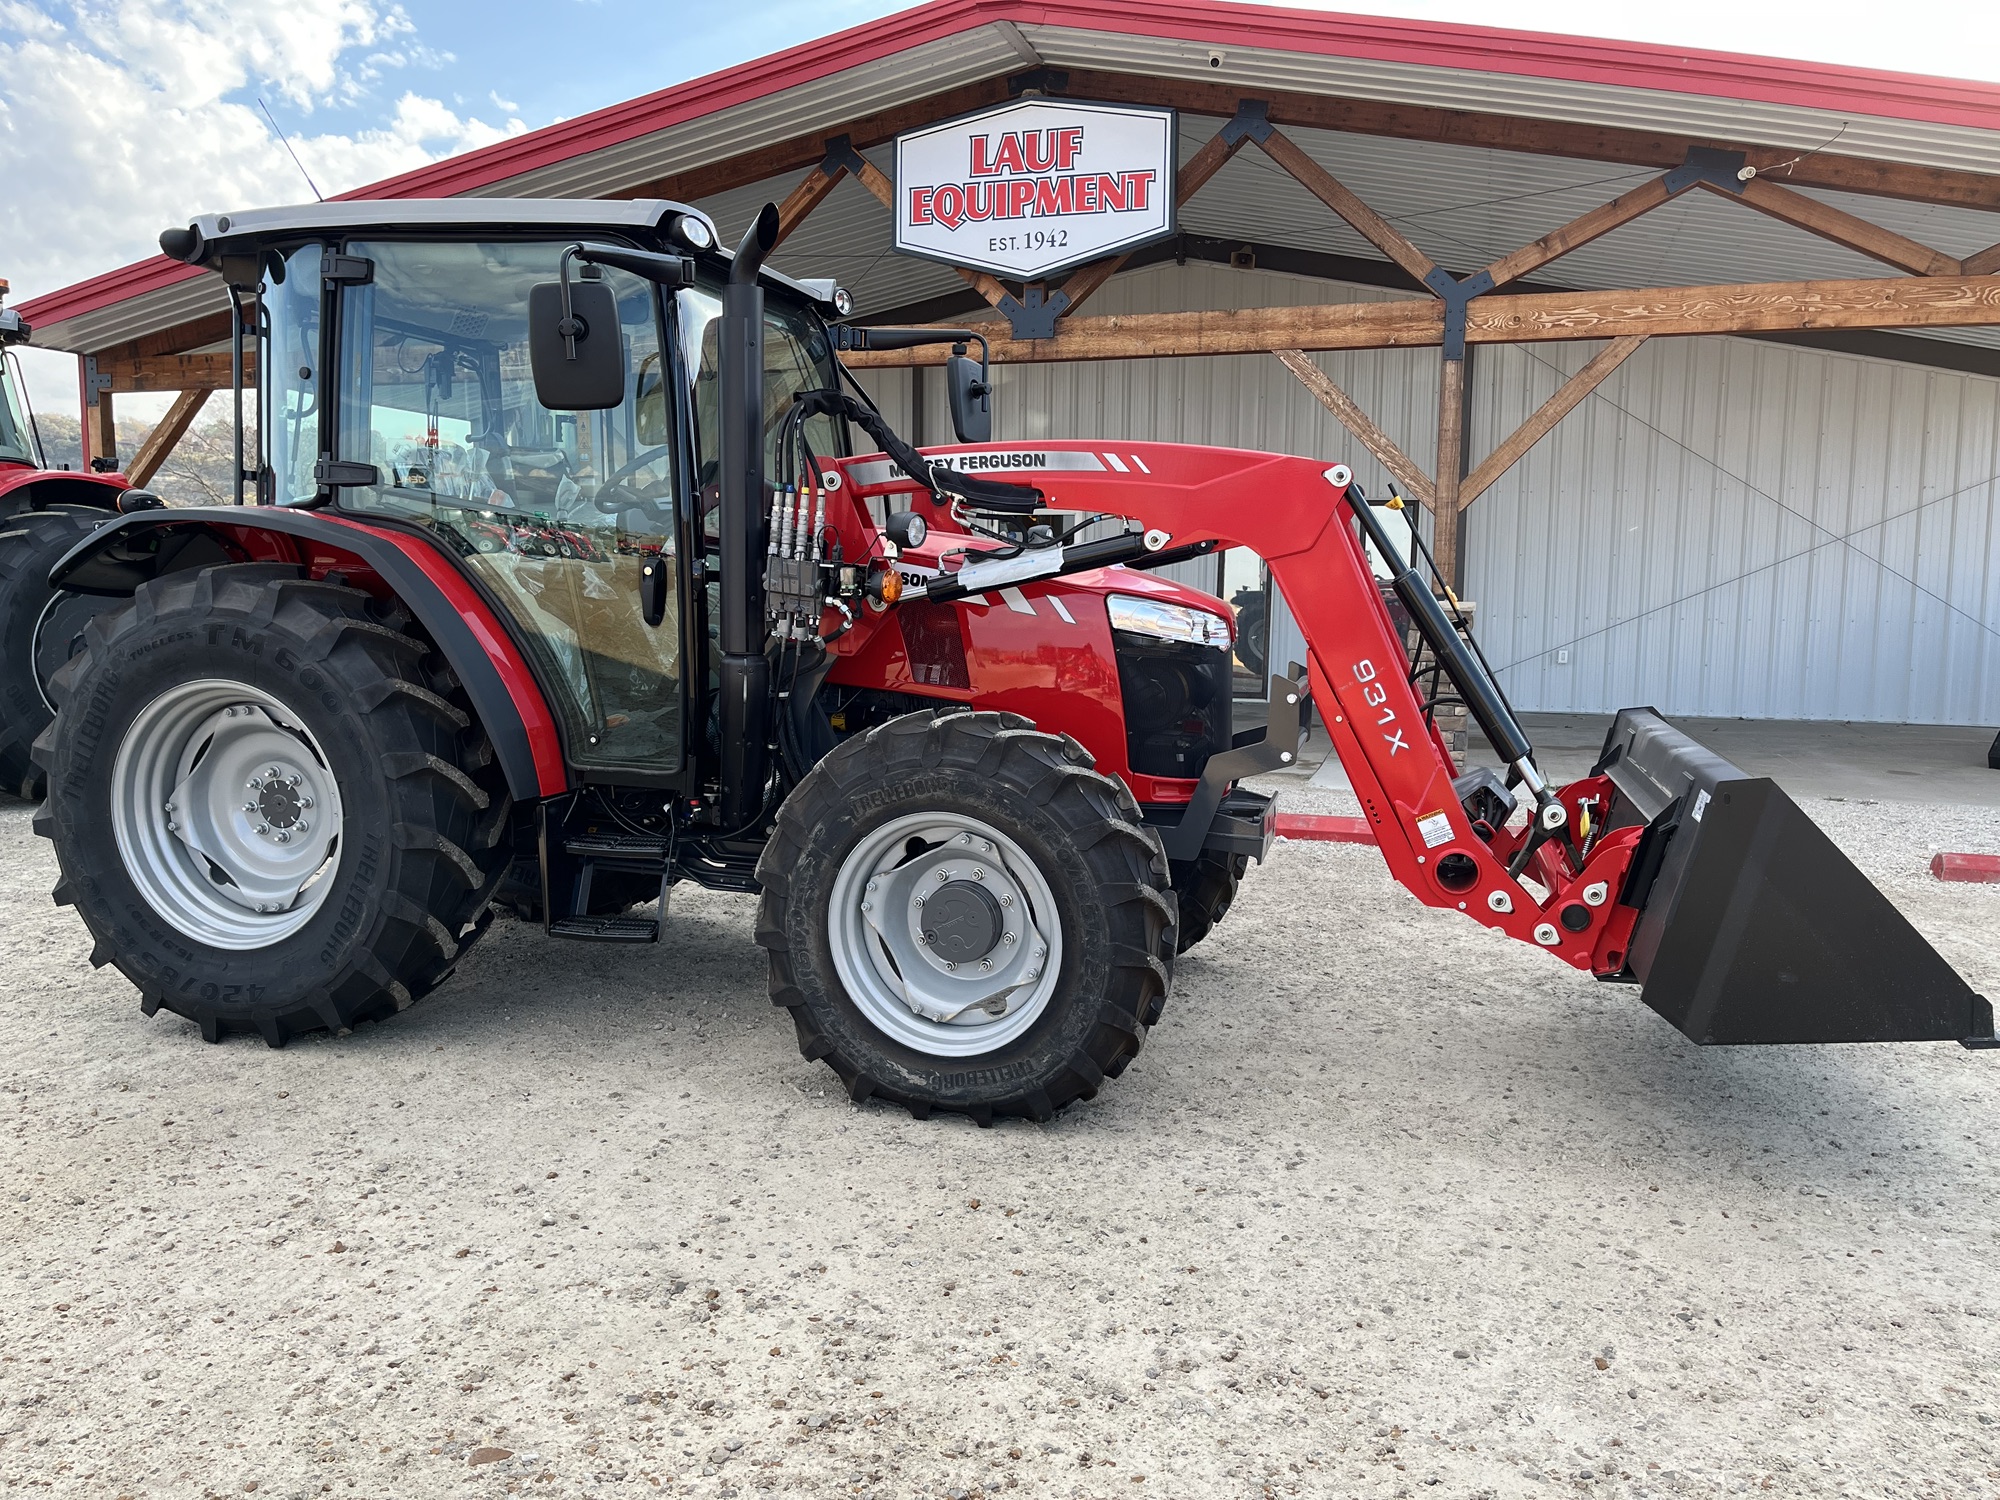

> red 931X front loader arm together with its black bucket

[{"left": 844, "top": 432, "right": 1994, "bottom": 1046}]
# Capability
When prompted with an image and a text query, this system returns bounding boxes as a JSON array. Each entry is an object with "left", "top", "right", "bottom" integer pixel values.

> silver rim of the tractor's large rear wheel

[{"left": 112, "top": 680, "right": 342, "bottom": 950}]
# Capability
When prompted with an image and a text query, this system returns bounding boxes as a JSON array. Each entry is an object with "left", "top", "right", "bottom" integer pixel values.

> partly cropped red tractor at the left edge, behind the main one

[{"left": 0, "top": 282, "right": 126, "bottom": 798}]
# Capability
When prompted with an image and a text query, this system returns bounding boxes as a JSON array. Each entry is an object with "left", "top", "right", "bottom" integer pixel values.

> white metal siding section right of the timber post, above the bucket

[{"left": 1466, "top": 338, "right": 2000, "bottom": 724}]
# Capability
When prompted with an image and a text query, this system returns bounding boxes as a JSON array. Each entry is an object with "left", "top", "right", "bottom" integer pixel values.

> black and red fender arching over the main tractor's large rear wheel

[{"left": 48, "top": 506, "right": 570, "bottom": 802}]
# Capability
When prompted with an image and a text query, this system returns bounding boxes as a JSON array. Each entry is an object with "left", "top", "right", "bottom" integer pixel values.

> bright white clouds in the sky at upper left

[{"left": 0, "top": 0, "right": 526, "bottom": 406}]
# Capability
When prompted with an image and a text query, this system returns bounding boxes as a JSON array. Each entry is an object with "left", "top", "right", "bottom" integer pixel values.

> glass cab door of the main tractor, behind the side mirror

[{"left": 336, "top": 240, "right": 688, "bottom": 782}]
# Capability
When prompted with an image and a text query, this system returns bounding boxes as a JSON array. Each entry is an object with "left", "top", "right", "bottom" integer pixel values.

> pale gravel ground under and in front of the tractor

[{"left": 0, "top": 794, "right": 2000, "bottom": 1500}]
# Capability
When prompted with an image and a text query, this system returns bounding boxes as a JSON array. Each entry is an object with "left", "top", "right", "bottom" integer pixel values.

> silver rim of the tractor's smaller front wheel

[{"left": 826, "top": 812, "right": 1062, "bottom": 1058}]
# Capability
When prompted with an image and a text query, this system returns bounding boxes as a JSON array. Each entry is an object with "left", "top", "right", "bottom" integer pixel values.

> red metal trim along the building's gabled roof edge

[{"left": 20, "top": 0, "right": 2000, "bottom": 338}]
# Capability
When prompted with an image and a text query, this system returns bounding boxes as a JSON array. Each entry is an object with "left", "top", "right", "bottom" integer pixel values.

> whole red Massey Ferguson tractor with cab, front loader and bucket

[{"left": 23, "top": 200, "right": 1994, "bottom": 1124}]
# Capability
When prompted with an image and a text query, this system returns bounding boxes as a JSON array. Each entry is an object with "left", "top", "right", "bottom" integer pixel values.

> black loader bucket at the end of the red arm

[{"left": 1598, "top": 708, "right": 1994, "bottom": 1046}]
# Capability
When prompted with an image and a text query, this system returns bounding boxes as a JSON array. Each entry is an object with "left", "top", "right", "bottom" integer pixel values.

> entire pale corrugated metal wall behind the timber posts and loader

[{"left": 852, "top": 262, "right": 2000, "bottom": 724}]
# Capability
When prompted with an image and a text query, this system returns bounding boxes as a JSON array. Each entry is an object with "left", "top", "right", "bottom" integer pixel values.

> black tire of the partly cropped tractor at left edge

[{"left": 0, "top": 504, "right": 126, "bottom": 802}]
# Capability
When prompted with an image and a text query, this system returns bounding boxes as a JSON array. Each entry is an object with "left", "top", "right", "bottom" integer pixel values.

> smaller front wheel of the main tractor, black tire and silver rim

[{"left": 758, "top": 710, "right": 1174, "bottom": 1126}]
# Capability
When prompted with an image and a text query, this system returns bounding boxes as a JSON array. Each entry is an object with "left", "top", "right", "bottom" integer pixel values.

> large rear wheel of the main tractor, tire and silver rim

[{"left": 34, "top": 562, "right": 510, "bottom": 1046}]
